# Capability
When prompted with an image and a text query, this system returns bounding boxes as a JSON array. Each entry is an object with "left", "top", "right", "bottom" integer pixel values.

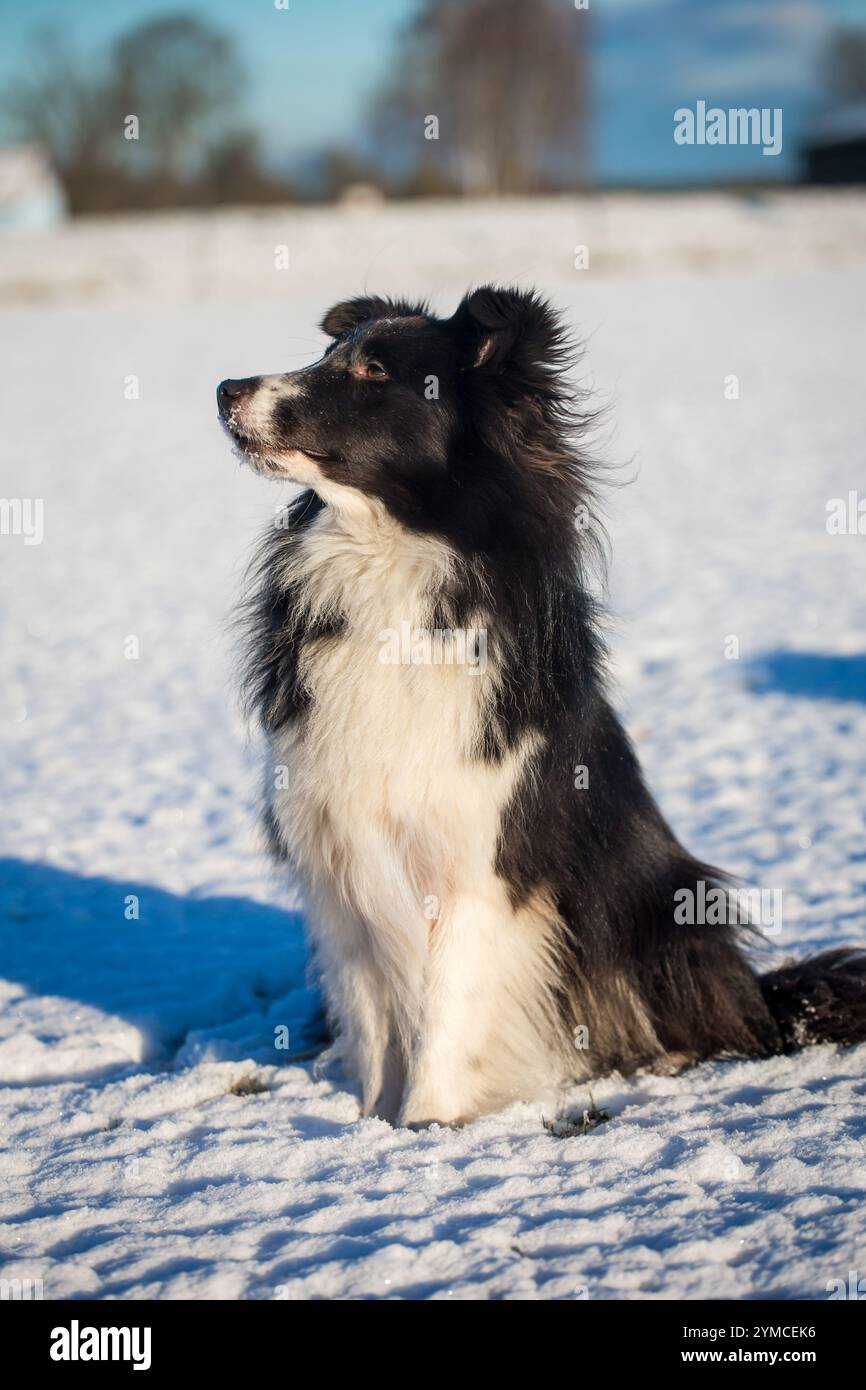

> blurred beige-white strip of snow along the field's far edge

[{"left": 0, "top": 189, "right": 866, "bottom": 304}]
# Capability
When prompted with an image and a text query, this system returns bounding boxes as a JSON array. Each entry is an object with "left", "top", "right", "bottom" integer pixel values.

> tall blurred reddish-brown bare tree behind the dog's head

[{"left": 374, "top": 0, "right": 589, "bottom": 195}]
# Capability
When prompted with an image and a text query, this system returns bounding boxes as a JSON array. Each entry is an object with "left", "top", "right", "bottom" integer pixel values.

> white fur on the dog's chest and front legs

[{"left": 272, "top": 500, "right": 561, "bottom": 1122}]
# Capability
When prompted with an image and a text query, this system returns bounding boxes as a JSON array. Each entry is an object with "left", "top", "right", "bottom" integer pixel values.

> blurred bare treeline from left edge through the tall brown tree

[{"left": 1, "top": 0, "right": 589, "bottom": 213}]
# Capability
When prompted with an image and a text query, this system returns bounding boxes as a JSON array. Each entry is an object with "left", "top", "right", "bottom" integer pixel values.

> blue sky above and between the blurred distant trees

[{"left": 0, "top": 0, "right": 866, "bottom": 182}]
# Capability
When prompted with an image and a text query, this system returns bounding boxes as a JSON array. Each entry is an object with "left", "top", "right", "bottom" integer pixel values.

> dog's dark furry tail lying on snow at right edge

[{"left": 759, "top": 947, "right": 866, "bottom": 1052}]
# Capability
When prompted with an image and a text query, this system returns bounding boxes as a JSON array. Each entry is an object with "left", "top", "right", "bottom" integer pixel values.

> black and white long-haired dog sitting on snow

[{"left": 218, "top": 288, "right": 866, "bottom": 1125}]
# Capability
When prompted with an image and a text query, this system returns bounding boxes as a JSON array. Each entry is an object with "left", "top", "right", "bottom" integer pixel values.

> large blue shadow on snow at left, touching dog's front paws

[{"left": 0, "top": 859, "right": 325, "bottom": 1063}]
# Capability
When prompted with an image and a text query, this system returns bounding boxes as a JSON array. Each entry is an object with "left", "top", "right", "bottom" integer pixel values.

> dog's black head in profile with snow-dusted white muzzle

[{"left": 217, "top": 286, "right": 575, "bottom": 530}]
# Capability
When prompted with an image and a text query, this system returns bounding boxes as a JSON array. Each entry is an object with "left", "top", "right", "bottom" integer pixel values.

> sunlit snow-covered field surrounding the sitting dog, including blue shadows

[{"left": 0, "top": 196, "right": 866, "bottom": 1300}]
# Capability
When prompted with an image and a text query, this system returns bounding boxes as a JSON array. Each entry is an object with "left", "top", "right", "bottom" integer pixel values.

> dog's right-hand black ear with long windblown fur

[{"left": 449, "top": 285, "right": 569, "bottom": 377}]
